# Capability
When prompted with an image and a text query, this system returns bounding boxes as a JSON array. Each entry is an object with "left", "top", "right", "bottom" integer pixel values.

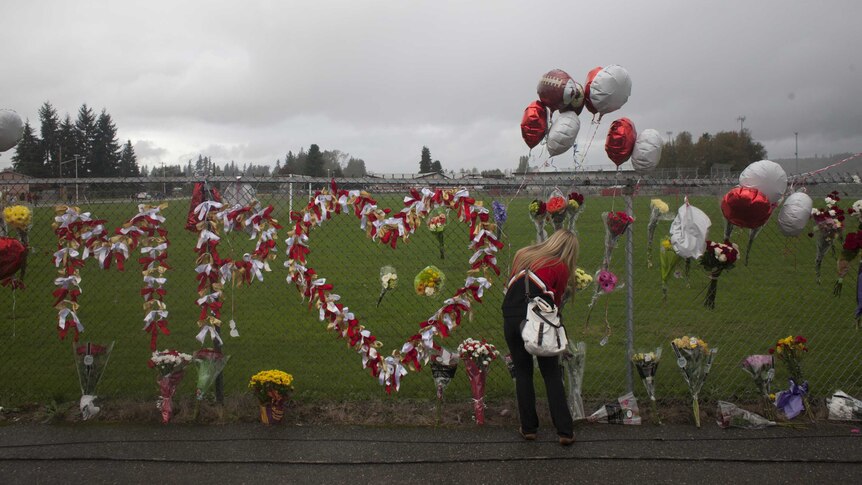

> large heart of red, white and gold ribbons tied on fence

[{"left": 284, "top": 181, "right": 503, "bottom": 393}]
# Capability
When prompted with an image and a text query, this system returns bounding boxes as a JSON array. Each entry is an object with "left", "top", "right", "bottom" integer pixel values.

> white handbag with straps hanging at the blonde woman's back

[{"left": 521, "top": 271, "right": 569, "bottom": 357}]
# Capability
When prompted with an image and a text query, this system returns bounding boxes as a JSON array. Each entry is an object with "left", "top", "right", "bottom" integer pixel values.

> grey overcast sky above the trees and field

[{"left": 0, "top": 0, "right": 862, "bottom": 172}]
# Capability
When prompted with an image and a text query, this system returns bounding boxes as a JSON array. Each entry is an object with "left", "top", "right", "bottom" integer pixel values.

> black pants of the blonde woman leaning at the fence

[{"left": 503, "top": 318, "right": 574, "bottom": 437}]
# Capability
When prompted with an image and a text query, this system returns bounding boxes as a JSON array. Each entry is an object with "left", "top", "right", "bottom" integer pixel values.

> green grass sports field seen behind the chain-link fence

[{"left": 0, "top": 186, "right": 862, "bottom": 405}]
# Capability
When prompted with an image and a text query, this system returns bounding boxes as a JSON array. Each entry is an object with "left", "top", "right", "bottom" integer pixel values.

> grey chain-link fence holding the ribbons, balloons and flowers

[{"left": 0, "top": 173, "right": 862, "bottom": 404}]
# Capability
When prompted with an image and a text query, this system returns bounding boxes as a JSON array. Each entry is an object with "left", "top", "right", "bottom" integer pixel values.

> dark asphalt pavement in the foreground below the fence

[{"left": 0, "top": 423, "right": 862, "bottom": 484}]
